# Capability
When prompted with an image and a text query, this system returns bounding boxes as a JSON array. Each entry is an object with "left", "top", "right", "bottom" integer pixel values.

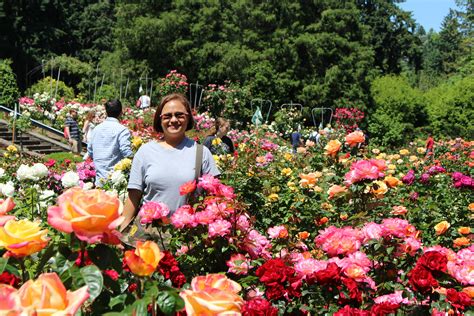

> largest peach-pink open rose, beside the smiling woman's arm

[{"left": 48, "top": 187, "right": 124, "bottom": 244}]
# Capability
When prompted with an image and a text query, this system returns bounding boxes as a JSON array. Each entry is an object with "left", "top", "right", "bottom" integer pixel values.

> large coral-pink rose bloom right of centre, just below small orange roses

[{"left": 344, "top": 159, "right": 387, "bottom": 186}]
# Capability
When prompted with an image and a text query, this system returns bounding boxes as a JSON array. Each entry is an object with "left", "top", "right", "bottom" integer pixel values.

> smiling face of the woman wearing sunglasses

[{"left": 160, "top": 100, "right": 189, "bottom": 138}]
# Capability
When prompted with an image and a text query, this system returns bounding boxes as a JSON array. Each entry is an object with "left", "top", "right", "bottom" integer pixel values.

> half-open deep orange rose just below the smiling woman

[{"left": 124, "top": 240, "right": 165, "bottom": 276}]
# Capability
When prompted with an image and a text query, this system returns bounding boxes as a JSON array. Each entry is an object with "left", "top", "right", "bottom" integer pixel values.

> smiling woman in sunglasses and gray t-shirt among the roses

[{"left": 121, "top": 94, "right": 220, "bottom": 229}]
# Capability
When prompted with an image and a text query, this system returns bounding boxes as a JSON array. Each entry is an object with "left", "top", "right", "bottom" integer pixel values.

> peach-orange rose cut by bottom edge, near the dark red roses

[{"left": 180, "top": 274, "right": 244, "bottom": 315}]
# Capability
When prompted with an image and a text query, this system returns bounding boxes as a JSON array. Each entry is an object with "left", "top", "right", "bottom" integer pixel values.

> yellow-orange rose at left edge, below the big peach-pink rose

[{"left": 0, "top": 219, "right": 49, "bottom": 257}]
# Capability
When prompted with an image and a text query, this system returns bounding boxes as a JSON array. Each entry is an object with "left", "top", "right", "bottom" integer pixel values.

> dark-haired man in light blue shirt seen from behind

[{"left": 87, "top": 100, "right": 133, "bottom": 187}]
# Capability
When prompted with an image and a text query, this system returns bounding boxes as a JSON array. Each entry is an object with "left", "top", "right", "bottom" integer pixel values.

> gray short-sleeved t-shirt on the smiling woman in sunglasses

[{"left": 128, "top": 137, "right": 220, "bottom": 213}]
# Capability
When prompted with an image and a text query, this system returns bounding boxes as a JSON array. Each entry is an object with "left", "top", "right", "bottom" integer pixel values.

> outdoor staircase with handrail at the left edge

[{"left": 0, "top": 120, "right": 69, "bottom": 156}]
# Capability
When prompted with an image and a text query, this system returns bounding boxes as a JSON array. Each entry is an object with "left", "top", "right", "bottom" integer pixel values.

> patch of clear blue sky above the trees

[{"left": 398, "top": 0, "right": 462, "bottom": 32}]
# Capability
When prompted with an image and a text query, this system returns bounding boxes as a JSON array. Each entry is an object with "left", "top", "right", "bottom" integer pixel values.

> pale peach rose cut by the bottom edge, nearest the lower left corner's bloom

[{"left": 18, "top": 273, "right": 89, "bottom": 315}]
